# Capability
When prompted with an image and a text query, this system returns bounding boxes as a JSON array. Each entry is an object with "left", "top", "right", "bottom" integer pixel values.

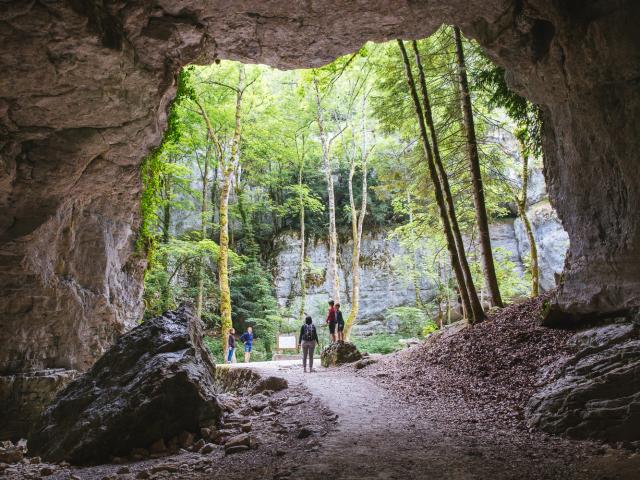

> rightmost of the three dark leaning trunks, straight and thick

[{"left": 453, "top": 27, "right": 503, "bottom": 307}]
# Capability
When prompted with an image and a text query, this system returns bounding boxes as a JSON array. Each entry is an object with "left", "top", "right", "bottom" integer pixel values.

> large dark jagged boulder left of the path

[{"left": 29, "top": 305, "right": 221, "bottom": 464}]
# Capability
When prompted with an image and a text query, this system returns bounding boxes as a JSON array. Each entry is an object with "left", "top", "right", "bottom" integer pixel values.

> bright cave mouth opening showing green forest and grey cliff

[{"left": 141, "top": 25, "right": 568, "bottom": 363}]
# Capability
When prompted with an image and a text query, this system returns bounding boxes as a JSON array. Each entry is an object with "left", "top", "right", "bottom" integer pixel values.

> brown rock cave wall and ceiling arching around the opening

[{"left": 0, "top": 0, "right": 640, "bottom": 373}]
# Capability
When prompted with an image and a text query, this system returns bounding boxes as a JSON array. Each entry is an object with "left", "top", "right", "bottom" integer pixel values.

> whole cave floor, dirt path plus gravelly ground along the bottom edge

[{"left": 7, "top": 361, "right": 640, "bottom": 480}]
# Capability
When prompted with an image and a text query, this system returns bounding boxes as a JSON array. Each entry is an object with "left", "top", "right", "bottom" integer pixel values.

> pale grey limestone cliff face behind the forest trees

[{"left": 275, "top": 214, "right": 568, "bottom": 335}]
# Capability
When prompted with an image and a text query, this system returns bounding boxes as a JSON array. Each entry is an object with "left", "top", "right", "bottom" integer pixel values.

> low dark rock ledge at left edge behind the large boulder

[{"left": 0, "top": 369, "right": 78, "bottom": 441}]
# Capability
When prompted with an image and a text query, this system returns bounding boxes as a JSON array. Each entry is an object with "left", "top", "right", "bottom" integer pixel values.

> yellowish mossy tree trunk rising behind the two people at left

[{"left": 218, "top": 65, "right": 244, "bottom": 352}]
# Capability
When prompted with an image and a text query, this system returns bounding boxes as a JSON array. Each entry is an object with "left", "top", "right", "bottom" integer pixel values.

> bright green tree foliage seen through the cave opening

[{"left": 142, "top": 26, "right": 540, "bottom": 344}]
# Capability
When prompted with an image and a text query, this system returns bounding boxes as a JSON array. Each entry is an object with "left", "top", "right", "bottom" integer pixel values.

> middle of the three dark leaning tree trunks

[{"left": 412, "top": 41, "right": 484, "bottom": 323}]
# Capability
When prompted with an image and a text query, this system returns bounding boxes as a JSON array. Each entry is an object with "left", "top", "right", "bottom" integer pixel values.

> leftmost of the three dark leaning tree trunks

[{"left": 398, "top": 40, "right": 474, "bottom": 322}]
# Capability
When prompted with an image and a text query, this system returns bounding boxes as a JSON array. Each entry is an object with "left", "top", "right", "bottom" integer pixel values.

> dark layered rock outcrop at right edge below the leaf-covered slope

[{"left": 527, "top": 321, "right": 640, "bottom": 442}]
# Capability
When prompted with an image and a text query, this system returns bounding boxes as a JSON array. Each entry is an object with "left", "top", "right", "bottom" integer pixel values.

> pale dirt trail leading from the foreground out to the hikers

[{"left": 246, "top": 362, "right": 640, "bottom": 480}]
